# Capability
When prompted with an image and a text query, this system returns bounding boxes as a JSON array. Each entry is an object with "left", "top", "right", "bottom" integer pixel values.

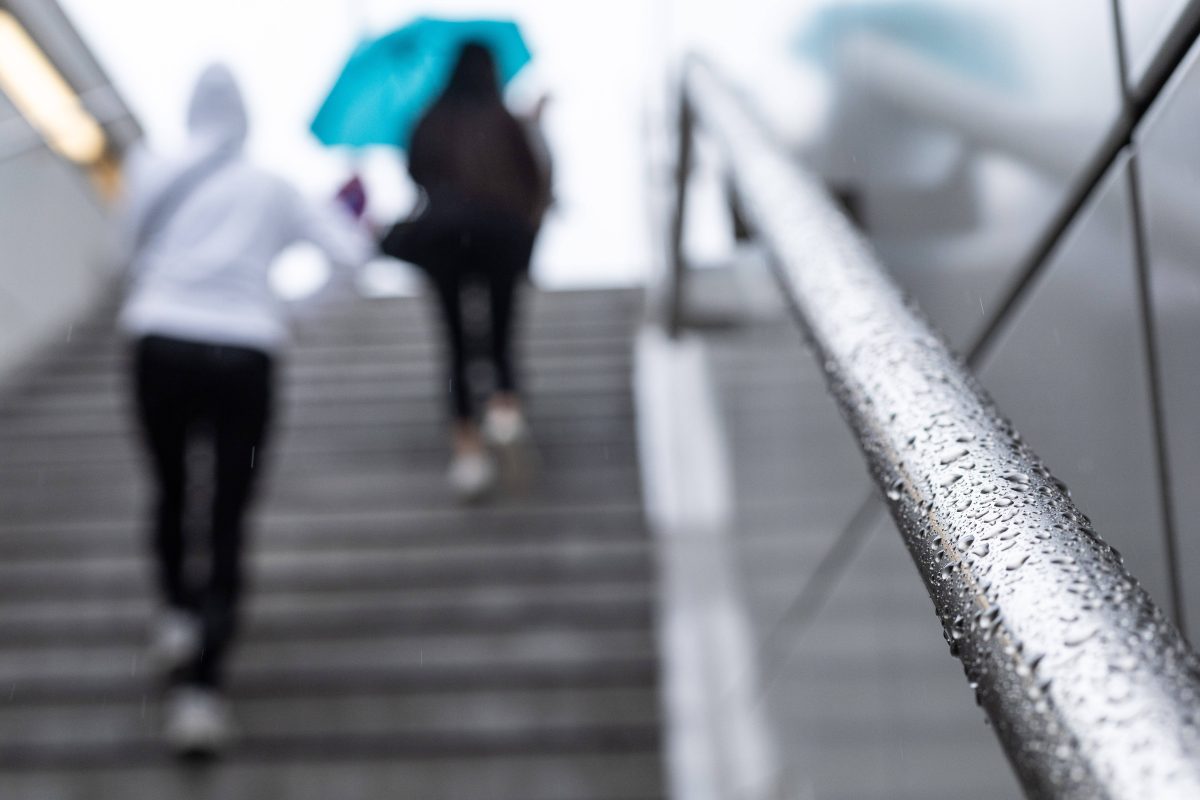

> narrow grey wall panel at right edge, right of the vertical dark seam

[{"left": 1138, "top": 34, "right": 1200, "bottom": 640}]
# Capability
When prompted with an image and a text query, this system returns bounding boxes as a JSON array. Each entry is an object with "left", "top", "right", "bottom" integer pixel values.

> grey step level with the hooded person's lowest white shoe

[{"left": 0, "top": 686, "right": 659, "bottom": 769}]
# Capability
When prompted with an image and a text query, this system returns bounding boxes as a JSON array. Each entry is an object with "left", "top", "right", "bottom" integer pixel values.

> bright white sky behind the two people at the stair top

[{"left": 61, "top": 0, "right": 661, "bottom": 285}]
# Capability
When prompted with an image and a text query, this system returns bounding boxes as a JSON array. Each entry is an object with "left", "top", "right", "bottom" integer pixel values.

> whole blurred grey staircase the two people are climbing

[{"left": 0, "top": 284, "right": 664, "bottom": 800}]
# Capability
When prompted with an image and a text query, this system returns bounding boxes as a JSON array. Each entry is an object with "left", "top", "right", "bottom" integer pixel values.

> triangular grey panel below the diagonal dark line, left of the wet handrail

[{"left": 767, "top": 519, "right": 1022, "bottom": 800}]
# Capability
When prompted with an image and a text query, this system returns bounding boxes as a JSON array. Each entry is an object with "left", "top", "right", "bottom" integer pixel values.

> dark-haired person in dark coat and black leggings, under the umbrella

[{"left": 380, "top": 43, "right": 550, "bottom": 499}]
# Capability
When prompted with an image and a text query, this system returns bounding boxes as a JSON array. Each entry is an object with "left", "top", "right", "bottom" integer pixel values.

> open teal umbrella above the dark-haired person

[{"left": 310, "top": 17, "right": 532, "bottom": 149}]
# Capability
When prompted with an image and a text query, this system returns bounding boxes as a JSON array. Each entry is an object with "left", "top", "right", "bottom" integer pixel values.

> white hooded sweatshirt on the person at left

[{"left": 118, "top": 65, "right": 374, "bottom": 353}]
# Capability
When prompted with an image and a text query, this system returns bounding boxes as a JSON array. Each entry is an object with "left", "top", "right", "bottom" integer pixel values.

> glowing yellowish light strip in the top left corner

[{"left": 0, "top": 11, "right": 107, "bottom": 164}]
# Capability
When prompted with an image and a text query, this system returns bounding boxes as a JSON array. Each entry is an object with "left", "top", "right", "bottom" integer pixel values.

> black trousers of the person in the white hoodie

[{"left": 134, "top": 336, "right": 272, "bottom": 687}]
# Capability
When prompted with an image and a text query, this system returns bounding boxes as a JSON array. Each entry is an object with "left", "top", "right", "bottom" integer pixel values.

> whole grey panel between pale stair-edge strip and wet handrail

[{"left": 689, "top": 251, "right": 1020, "bottom": 800}]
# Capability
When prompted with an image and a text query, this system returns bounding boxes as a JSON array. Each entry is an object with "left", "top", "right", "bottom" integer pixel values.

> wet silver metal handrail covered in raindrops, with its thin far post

[{"left": 667, "top": 58, "right": 1200, "bottom": 800}]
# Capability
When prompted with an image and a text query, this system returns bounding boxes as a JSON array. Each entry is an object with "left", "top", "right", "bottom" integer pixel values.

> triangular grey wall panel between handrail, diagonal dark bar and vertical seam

[{"left": 982, "top": 161, "right": 1171, "bottom": 608}]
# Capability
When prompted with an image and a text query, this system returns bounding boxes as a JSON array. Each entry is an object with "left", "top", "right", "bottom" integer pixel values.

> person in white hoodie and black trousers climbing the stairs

[{"left": 118, "top": 65, "right": 374, "bottom": 753}]
